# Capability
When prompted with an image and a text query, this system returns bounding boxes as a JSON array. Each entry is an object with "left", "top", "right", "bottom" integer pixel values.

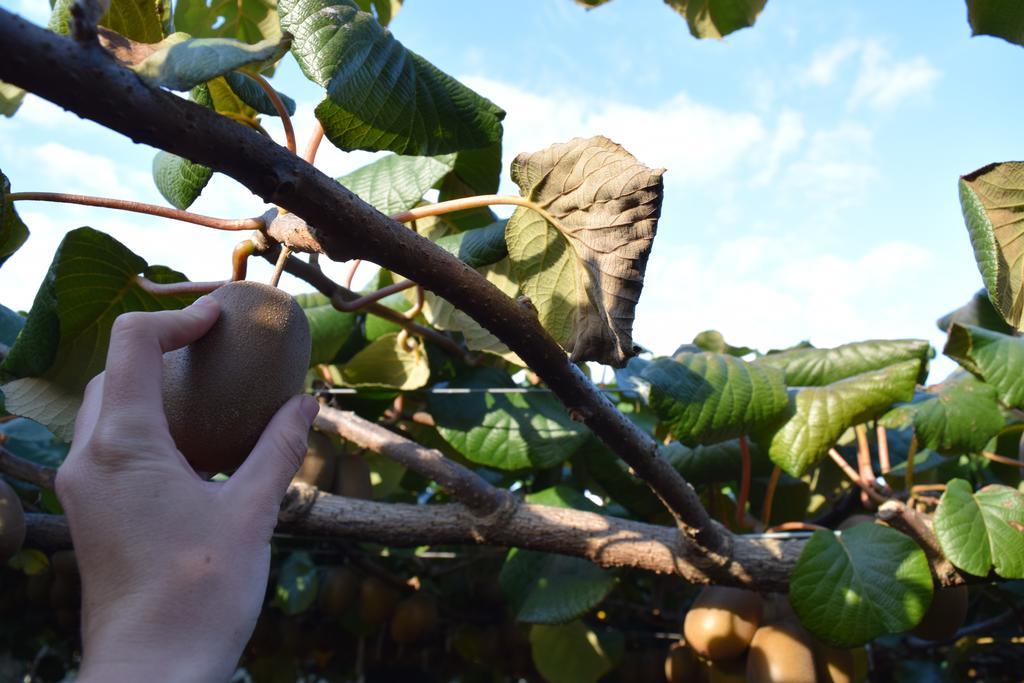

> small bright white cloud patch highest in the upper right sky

[{"left": 850, "top": 42, "right": 940, "bottom": 110}]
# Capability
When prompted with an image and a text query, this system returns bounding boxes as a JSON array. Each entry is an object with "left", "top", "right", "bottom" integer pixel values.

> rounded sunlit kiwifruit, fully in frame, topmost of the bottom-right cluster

[{"left": 683, "top": 586, "right": 762, "bottom": 660}]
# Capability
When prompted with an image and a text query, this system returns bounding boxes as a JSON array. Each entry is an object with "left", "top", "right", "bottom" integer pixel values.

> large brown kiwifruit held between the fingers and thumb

[{"left": 164, "top": 281, "right": 310, "bottom": 472}]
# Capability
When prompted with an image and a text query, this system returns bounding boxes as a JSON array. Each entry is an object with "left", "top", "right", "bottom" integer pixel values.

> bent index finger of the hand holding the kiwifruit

[{"left": 102, "top": 297, "right": 220, "bottom": 416}]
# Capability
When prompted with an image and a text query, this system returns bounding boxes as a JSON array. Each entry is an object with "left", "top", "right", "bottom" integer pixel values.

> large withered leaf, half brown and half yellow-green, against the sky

[{"left": 505, "top": 136, "right": 664, "bottom": 368}]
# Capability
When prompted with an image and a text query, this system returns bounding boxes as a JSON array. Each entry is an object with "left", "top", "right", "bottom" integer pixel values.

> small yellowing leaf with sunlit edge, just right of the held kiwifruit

[{"left": 341, "top": 332, "right": 430, "bottom": 391}]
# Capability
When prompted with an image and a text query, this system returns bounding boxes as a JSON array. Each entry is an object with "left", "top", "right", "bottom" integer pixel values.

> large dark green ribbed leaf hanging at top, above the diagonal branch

[{"left": 280, "top": 0, "right": 505, "bottom": 156}]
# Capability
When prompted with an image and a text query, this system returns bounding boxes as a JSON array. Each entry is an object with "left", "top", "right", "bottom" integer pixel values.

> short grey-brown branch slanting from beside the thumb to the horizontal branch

[{"left": 313, "top": 405, "right": 515, "bottom": 516}]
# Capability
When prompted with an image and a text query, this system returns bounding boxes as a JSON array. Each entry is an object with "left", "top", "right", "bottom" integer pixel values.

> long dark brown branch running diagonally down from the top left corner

[{"left": 0, "top": 9, "right": 729, "bottom": 548}]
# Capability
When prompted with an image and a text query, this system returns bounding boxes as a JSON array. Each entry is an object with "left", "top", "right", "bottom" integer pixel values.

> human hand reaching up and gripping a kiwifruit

[{"left": 56, "top": 297, "right": 317, "bottom": 683}]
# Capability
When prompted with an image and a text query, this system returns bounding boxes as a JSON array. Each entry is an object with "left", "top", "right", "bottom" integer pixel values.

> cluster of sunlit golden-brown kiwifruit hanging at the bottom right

[{"left": 665, "top": 586, "right": 867, "bottom": 683}]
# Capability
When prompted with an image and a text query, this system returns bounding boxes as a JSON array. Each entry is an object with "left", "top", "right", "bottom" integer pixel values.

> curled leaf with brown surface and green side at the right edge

[{"left": 959, "top": 162, "right": 1024, "bottom": 330}]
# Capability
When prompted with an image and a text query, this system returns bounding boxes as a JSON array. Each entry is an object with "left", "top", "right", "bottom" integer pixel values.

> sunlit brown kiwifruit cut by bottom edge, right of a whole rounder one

[{"left": 746, "top": 620, "right": 817, "bottom": 683}]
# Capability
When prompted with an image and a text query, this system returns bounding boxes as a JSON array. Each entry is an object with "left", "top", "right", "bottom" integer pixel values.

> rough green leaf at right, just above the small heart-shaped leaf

[{"left": 908, "top": 373, "right": 1006, "bottom": 455}]
